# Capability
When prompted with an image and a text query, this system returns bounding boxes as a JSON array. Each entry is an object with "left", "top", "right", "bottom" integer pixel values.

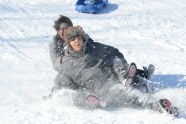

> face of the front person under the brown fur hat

[{"left": 70, "top": 37, "right": 83, "bottom": 52}]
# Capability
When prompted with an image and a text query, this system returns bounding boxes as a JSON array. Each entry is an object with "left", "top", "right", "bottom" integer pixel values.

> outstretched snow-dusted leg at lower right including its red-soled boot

[{"left": 106, "top": 84, "right": 178, "bottom": 116}]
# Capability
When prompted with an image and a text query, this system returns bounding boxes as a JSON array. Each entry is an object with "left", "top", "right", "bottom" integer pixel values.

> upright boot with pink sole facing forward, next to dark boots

[{"left": 125, "top": 63, "right": 137, "bottom": 87}]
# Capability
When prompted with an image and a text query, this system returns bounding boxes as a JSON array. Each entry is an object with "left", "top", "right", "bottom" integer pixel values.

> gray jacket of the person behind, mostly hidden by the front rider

[{"left": 49, "top": 34, "right": 93, "bottom": 71}]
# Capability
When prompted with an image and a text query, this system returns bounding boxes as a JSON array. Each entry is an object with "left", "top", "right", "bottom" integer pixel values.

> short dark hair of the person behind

[{"left": 54, "top": 15, "right": 73, "bottom": 31}]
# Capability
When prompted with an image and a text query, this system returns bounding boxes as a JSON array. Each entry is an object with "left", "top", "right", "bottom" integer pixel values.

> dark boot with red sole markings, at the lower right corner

[{"left": 159, "top": 99, "right": 178, "bottom": 117}]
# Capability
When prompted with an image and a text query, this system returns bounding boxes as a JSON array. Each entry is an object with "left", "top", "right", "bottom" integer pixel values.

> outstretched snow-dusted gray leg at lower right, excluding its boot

[{"left": 106, "top": 84, "right": 159, "bottom": 110}]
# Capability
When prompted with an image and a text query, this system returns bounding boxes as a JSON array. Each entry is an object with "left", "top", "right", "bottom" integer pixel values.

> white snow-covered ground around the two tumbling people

[{"left": 0, "top": 0, "right": 186, "bottom": 124}]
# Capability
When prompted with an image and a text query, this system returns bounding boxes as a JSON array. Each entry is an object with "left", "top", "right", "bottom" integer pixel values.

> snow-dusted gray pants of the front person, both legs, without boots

[{"left": 74, "top": 82, "right": 159, "bottom": 110}]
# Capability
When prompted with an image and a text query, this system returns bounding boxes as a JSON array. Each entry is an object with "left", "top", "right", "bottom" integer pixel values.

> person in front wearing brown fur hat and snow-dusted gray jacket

[{"left": 52, "top": 27, "right": 179, "bottom": 116}]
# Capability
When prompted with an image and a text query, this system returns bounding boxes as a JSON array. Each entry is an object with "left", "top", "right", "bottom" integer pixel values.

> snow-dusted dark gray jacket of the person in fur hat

[{"left": 55, "top": 38, "right": 128, "bottom": 93}]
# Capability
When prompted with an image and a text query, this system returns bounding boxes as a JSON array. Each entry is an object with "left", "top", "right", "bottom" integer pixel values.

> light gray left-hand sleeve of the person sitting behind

[{"left": 49, "top": 42, "right": 61, "bottom": 71}]
